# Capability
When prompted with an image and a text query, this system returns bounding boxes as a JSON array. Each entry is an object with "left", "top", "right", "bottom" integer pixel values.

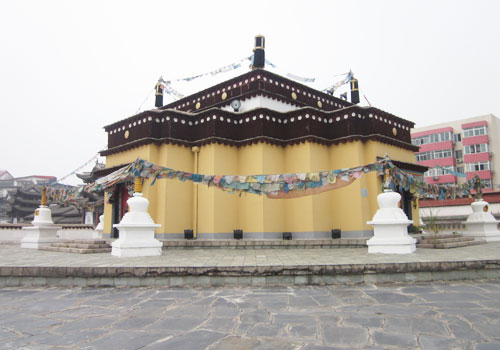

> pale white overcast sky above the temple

[{"left": 0, "top": 0, "right": 500, "bottom": 183}]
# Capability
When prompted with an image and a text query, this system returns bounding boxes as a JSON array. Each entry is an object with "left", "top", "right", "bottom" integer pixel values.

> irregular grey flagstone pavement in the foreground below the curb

[{"left": 0, "top": 281, "right": 500, "bottom": 350}]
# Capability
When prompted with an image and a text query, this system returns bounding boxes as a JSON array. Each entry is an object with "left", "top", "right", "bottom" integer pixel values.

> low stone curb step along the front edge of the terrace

[{"left": 0, "top": 260, "right": 500, "bottom": 287}]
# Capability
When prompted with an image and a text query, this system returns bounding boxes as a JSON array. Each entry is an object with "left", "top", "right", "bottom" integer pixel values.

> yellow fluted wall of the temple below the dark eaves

[{"left": 104, "top": 141, "right": 418, "bottom": 238}]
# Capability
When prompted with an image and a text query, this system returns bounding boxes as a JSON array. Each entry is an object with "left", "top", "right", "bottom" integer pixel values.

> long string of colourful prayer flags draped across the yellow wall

[{"left": 47, "top": 158, "right": 482, "bottom": 206}]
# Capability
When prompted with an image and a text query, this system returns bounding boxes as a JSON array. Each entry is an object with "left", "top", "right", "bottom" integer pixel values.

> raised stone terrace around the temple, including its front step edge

[{"left": 0, "top": 242, "right": 500, "bottom": 287}]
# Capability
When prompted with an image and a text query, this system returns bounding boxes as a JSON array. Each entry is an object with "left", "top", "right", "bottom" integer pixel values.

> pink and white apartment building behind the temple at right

[{"left": 411, "top": 114, "right": 500, "bottom": 191}]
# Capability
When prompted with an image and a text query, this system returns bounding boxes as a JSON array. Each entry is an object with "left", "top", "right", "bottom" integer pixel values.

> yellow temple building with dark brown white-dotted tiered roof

[{"left": 101, "top": 36, "right": 427, "bottom": 239}]
